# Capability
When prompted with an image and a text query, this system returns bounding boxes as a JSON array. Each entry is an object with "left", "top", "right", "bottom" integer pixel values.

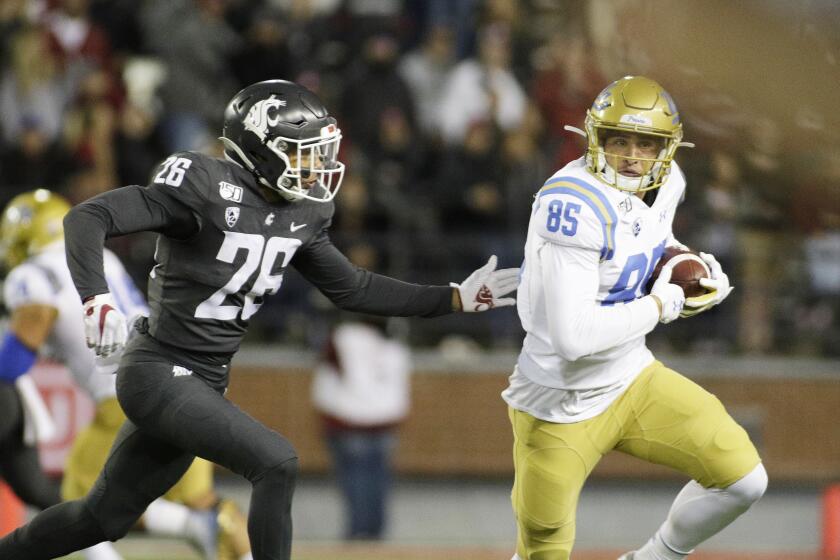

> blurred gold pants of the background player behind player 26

[{"left": 61, "top": 398, "right": 213, "bottom": 505}]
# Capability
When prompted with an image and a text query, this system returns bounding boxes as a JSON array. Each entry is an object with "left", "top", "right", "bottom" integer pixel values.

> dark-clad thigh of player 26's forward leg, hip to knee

[{"left": 117, "top": 361, "right": 296, "bottom": 479}]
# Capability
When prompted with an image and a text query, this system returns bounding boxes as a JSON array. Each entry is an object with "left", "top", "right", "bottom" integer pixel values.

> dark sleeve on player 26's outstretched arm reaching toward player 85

[{"left": 292, "top": 231, "right": 452, "bottom": 317}]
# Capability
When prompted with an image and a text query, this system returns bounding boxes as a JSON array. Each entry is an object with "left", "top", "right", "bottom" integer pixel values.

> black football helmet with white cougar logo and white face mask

[{"left": 220, "top": 80, "right": 344, "bottom": 202}]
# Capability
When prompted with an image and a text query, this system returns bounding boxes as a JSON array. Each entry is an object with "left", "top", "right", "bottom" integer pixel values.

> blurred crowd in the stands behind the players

[{"left": 0, "top": 0, "right": 840, "bottom": 355}]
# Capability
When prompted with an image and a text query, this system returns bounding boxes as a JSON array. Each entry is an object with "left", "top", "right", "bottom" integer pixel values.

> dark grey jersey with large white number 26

[{"left": 143, "top": 153, "right": 333, "bottom": 352}]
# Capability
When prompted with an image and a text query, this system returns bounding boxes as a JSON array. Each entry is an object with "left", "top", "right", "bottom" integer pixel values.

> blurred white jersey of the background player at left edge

[{"left": 3, "top": 242, "right": 148, "bottom": 402}]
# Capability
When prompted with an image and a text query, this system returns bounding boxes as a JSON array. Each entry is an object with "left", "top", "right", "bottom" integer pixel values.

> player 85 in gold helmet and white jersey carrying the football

[{"left": 502, "top": 76, "right": 767, "bottom": 560}]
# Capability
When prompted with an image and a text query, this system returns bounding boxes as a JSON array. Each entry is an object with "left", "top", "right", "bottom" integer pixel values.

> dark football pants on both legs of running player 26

[{"left": 0, "top": 335, "right": 297, "bottom": 560}]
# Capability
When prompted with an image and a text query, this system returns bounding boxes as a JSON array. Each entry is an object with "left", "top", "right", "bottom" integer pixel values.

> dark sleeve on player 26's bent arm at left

[{"left": 64, "top": 186, "right": 200, "bottom": 299}]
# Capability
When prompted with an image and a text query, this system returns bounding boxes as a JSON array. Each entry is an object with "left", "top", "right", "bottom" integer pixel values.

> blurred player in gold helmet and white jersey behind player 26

[{"left": 0, "top": 189, "right": 250, "bottom": 560}]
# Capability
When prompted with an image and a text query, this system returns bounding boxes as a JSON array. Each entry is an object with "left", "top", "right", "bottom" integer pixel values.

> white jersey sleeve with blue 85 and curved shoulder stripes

[{"left": 531, "top": 180, "right": 618, "bottom": 261}]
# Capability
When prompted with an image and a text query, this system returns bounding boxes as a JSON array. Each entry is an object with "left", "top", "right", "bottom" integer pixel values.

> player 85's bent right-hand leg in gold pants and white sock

[{"left": 617, "top": 362, "right": 767, "bottom": 560}]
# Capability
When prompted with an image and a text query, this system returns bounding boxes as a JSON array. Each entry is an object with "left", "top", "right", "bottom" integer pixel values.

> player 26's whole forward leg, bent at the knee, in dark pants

[{"left": 117, "top": 362, "right": 298, "bottom": 559}]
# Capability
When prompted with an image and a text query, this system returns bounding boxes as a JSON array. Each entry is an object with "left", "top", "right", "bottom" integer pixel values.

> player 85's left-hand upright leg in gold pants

[{"left": 508, "top": 409, "right": 601, "bottom": 560}]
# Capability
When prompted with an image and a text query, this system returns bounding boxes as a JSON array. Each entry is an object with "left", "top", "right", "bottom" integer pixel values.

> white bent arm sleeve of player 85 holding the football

[{"left": 540, "top": 244, "right": 659, "bottom": 361}]
